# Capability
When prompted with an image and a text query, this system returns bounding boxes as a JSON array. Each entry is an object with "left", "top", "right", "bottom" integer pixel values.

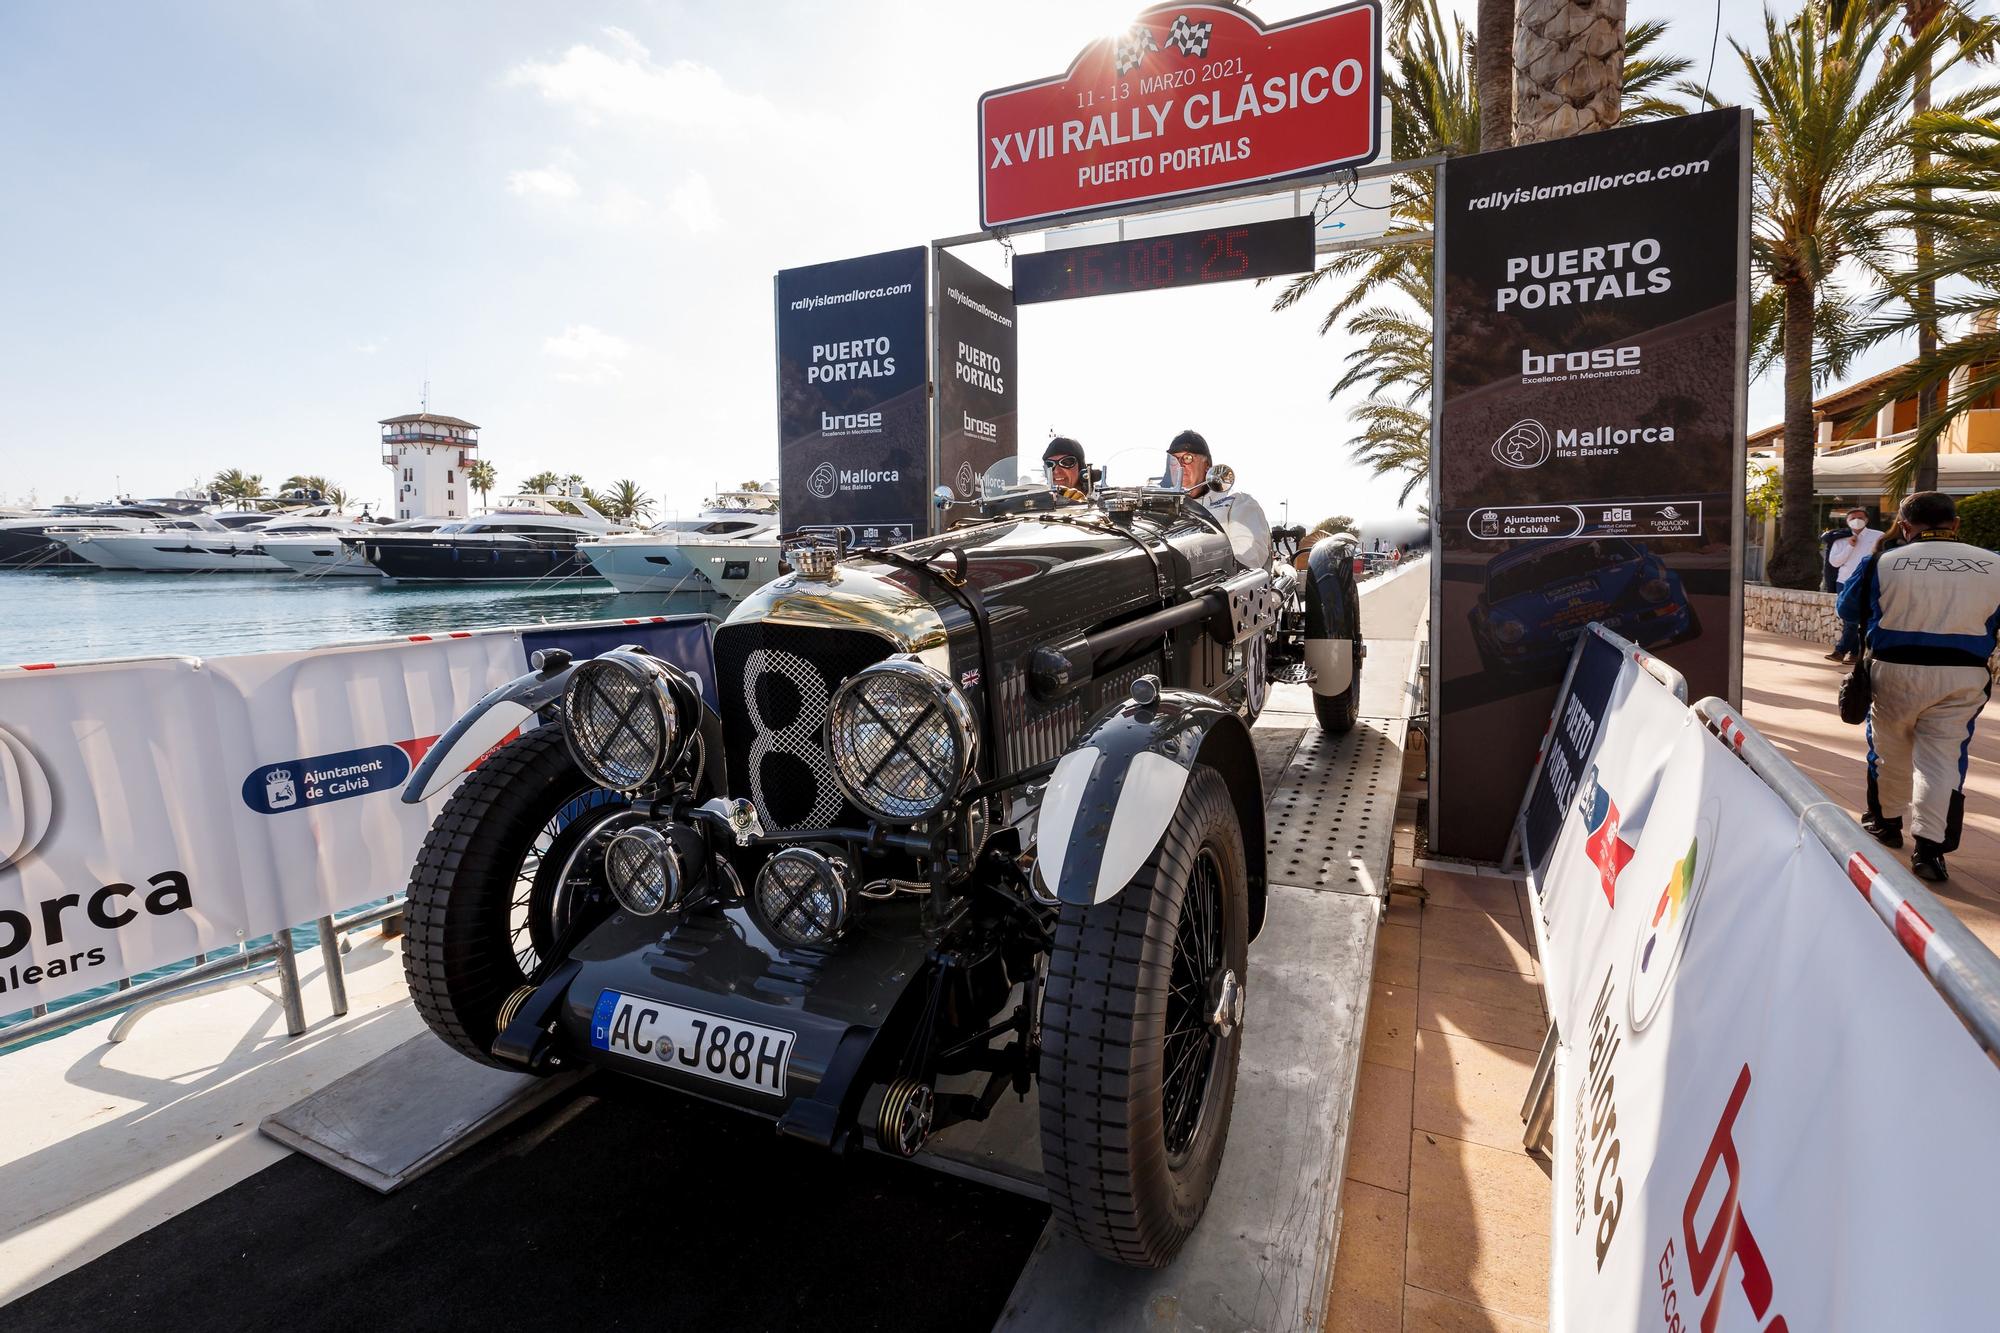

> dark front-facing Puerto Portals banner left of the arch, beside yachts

[{"left": 776, "top": 246, "right": 930, "bottom": 546}]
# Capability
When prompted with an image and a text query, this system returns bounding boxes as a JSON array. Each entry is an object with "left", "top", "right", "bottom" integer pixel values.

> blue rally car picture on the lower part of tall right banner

[{"left": 1470, "top": 536, "right": 1702, "bottom": 671}]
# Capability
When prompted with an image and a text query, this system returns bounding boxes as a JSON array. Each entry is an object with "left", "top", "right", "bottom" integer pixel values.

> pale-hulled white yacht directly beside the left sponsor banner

[{"left": 576, "top": 490, "right": 780, "bottom": 600}]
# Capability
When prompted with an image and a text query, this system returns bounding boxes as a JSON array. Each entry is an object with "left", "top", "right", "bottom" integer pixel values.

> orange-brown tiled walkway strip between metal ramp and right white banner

[{"left": 1324, "top": 732, "right": 1550, "bottom": 1333}]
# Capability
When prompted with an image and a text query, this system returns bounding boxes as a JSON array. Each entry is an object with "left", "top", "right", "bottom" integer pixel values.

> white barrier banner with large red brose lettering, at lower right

[{"left": 1542, "top": 675, "right": 2000, "bottom": 1333}]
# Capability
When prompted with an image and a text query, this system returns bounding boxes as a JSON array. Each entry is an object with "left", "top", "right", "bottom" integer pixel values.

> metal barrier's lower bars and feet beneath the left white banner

[{"left": 0, "top": 899, "right": 406, "bottom": 1055}]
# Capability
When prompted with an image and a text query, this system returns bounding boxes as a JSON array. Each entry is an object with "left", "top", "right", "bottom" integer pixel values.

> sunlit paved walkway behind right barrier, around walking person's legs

[{"left": 1744, "top": 630, "right": 2000, "bottom": 953}]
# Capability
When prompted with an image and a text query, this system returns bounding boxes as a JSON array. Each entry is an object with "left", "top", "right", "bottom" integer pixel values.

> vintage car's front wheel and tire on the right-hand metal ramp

[{"left": 1038, "top": 767, "right": 1250, "bottom": 1267}]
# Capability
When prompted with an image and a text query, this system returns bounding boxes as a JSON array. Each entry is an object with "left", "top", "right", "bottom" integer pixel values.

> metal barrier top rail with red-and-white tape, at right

[{"left": 1692, "top": 699, "right": 2000, "bottom": 1059}]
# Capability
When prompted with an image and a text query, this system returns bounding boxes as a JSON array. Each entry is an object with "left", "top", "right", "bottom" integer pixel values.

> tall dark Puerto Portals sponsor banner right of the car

[{"left": 1430, "top": 101, "right": 1750, "bottom": 859}]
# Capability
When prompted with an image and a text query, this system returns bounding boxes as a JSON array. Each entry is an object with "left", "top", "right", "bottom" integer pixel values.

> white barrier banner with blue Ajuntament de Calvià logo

[{"left": 0, "top": 618, "right": 714, "bottom": 1015}]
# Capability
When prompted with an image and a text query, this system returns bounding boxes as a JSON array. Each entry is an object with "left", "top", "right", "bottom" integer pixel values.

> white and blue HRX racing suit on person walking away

[{"left": 1840, "top": 536, "right": 2000, "bottom": 853}]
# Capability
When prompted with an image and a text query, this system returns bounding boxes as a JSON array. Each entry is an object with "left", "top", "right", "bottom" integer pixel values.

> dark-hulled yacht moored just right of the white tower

[{"left": 342, "top": 494, "right": 638, "bottom": 582}]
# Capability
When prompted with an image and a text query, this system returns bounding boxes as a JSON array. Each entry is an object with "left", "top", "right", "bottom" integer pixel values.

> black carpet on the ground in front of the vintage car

[{"left": 0, "top": 1075, "right": 1048, "bottom": 1333}]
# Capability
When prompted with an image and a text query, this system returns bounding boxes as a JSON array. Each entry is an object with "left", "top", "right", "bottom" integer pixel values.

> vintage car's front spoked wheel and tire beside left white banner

[{"left": 402, "top": 727, "right": 630, "bottom": 1065}]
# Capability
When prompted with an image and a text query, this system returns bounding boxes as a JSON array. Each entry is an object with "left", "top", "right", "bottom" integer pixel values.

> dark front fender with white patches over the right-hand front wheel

[{"left": 1036, "top": 691, "right": 1264, "bottom": 929}]
